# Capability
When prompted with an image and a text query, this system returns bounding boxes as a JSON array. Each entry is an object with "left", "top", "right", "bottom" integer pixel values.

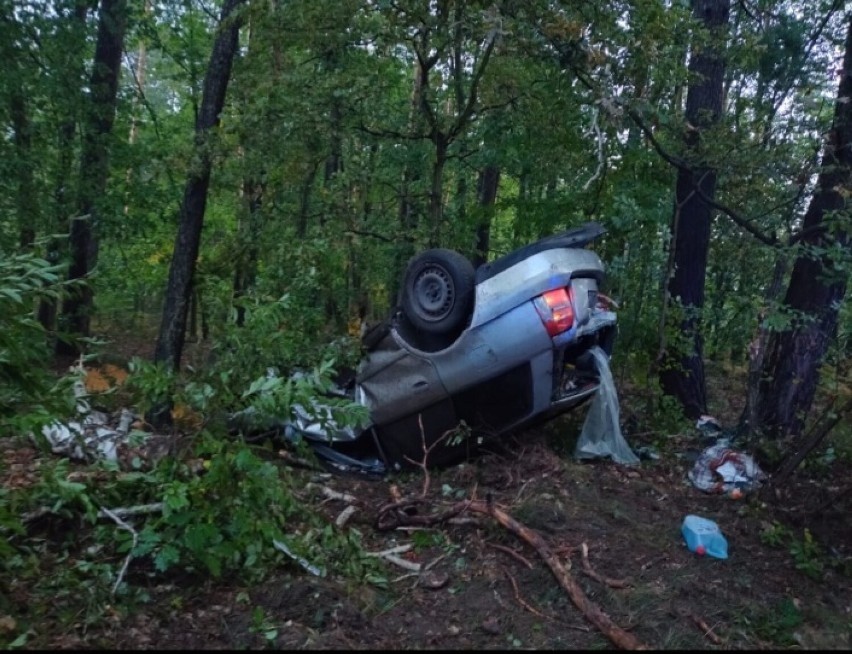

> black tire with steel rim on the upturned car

[{"left": 400, "top": 248, "right": 475, "bottom": 334}]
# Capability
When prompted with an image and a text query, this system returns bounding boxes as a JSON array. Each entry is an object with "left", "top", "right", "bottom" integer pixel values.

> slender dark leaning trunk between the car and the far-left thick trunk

[{"left": 154, "top": 0, "right": 244, "bottom": 374}]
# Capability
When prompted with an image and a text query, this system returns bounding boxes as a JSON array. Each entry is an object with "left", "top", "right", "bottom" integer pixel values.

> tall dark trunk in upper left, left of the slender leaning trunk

[{"left": 56, "top": 0, "right": 127, "bottom": 356}]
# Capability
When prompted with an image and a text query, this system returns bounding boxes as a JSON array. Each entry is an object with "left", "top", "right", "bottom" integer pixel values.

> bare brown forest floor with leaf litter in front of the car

[{"left": 0, "top": 344, "right": 852, "bottom": 650}]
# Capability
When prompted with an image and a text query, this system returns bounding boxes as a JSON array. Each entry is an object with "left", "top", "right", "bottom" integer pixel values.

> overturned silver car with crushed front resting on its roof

[{"left": 278, "top": 223, "right": 616, "bottom": 473}]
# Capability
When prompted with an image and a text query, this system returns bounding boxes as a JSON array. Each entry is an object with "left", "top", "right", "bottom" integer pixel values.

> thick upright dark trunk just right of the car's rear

[{"left": 660, "top": 0, "right": 730, "bottom": 419}]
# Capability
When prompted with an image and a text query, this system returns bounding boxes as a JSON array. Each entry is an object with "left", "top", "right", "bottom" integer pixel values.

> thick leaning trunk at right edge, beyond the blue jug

[{"left": 747, "top": 17, "right": 852, "bottom": 438}]
